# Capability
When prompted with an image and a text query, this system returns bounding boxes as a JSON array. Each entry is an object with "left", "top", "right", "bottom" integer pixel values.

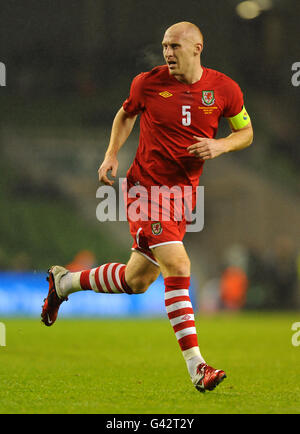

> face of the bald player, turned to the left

[{"left": 162, "top": 31, "right": 195, "bottom": 76}]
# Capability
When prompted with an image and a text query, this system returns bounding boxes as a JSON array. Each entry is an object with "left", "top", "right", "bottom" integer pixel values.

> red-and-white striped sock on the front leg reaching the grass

[{"left": 164, "top": 276, "right": 205, "bottom": 377}]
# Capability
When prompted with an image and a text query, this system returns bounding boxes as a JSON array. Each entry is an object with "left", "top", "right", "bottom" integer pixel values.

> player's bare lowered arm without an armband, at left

[{"left": 98, "top": 107, "right": 137, "bottom": 185}]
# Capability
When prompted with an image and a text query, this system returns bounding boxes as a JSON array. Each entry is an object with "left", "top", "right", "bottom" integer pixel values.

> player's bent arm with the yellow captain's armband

[{"left": 187, "top": 107, "right": 253, "bottom": 160}]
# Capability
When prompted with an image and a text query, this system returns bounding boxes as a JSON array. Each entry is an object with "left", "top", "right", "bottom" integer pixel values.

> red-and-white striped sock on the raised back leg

[{"left": 60, "top": 263, "right": 132, "bottom": 296}]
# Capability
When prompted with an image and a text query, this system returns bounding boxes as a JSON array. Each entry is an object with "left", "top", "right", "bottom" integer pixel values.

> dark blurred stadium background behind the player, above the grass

[{"left": 0, "top": 0, "right": 300, "bottom": 317}]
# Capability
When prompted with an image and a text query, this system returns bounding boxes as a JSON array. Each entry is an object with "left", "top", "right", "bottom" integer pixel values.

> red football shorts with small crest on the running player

[{"left": 123, "top": 179, "right": 186, "bottom": 265}]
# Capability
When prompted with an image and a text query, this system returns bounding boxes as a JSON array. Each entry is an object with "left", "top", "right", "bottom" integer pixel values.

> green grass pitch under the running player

[{"left": 0, "top": 312, "right": 300, "bottom": 414}]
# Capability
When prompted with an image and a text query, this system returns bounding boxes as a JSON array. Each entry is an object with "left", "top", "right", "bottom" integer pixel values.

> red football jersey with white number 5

[{"left": 123, "top": 65, "right": 244, "bottom": 192}]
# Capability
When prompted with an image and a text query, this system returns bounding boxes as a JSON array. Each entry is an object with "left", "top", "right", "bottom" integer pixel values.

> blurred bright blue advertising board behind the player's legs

[{"left": 0, "top": 271, "right": 196, "bottom": 318}]
